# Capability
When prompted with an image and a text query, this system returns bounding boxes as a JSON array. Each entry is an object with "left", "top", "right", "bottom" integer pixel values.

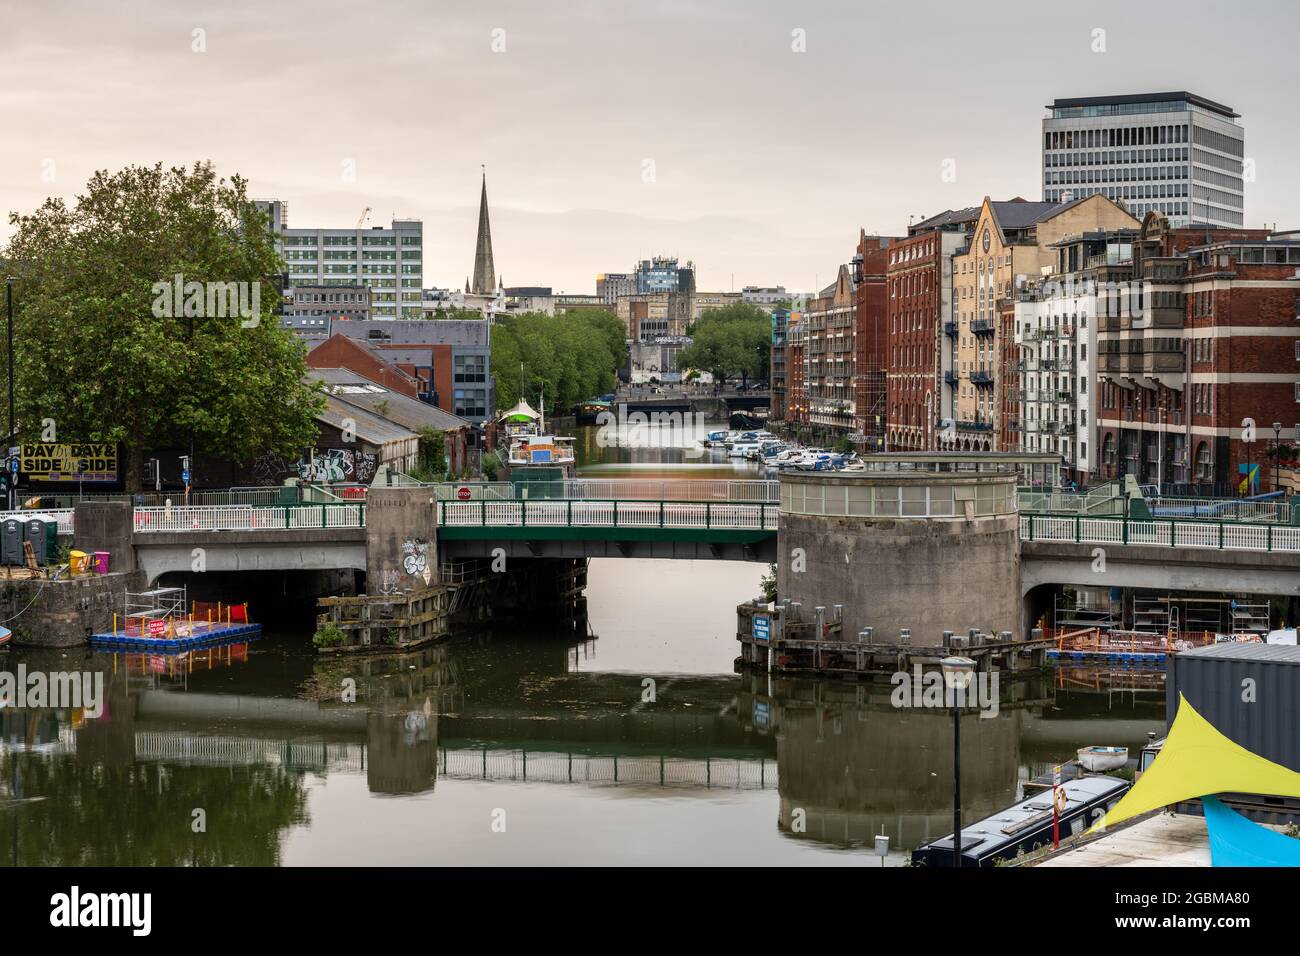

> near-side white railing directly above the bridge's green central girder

[{"left": 438, "top": 498, "right": 780, "bottom": 531}]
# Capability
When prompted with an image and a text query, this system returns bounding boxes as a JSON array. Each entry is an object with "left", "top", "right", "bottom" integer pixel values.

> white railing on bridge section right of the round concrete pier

[{"left": 1021, "top": 515, "right": 1300, "bottom": 553}]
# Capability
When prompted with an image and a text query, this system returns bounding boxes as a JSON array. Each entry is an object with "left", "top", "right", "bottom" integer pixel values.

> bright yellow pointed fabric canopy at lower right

[{"left": 1092, "top": 695, "right": 1300, "bottom": 830}]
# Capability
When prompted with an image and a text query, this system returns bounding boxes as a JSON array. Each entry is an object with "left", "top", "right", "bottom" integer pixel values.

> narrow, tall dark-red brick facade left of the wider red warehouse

[{"left": 853, "top": 230, "right": 898, "bottom": 451}]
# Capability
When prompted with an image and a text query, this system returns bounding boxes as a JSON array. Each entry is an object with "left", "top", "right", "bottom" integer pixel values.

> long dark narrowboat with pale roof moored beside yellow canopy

[{"left": 911, "top": 774, "right": 1130, "bottom": 866}]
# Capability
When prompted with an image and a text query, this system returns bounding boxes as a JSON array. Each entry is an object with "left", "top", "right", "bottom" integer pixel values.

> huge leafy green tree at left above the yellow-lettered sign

[{"left": 7, "top": 163, "right": 324, "bottom": 489}]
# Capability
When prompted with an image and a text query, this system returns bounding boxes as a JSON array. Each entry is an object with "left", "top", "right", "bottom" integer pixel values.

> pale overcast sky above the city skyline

[{"left": 0, "top": 0, "right": 1300, "bottom": 293}]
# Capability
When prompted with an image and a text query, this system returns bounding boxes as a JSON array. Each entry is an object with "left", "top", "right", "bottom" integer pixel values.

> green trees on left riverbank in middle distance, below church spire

[{"left": 491, "top": 311, "right": 628, "bottom": 410}]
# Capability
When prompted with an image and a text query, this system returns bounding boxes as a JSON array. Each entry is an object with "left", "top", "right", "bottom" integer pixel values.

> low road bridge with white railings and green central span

[{"left": 27, "top": 479, "right": 1300, "bottom": 594}]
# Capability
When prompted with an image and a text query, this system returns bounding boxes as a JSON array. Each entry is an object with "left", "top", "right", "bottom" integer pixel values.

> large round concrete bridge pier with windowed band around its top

[{"left": 776, "top": 468, "right": 1023, "bottom": 646}]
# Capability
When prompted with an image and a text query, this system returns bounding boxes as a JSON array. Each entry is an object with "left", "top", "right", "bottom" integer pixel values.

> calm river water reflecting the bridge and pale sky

[{"left": 0, "top": 428, "right": 1164, "bottom": 866}]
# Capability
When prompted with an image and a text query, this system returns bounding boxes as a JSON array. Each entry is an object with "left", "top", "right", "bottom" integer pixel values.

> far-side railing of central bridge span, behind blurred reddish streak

[{"left": 430, "top": 479, "right": 781, "bottom": 505}]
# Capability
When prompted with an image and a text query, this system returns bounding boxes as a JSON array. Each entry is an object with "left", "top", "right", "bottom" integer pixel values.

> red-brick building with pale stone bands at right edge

[{"left": 1097, "top": 213, "right": 1300, "bottom": 493}]
